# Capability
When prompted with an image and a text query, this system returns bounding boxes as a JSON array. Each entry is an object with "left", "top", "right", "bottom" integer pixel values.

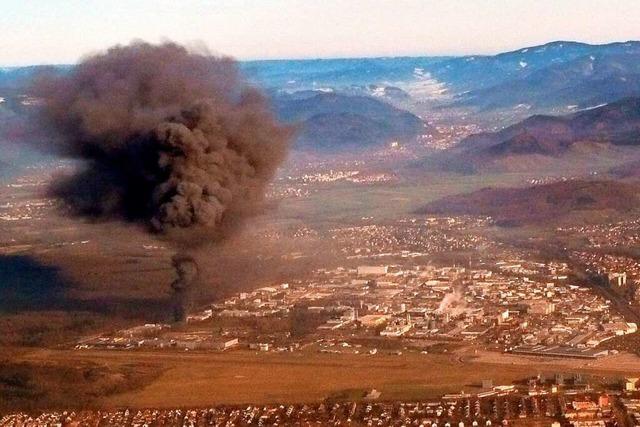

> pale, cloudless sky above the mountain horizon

[{"left": 0, "top": 0, "right": 640, "bottom": 65}]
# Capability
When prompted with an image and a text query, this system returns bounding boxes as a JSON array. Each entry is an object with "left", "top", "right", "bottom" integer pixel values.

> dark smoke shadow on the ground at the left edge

[{"left": 0, "top": 255, "right": 171, "bottom": 320}]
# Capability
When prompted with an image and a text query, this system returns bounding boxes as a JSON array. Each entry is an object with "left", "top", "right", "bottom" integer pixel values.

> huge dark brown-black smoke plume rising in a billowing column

[{"left": 35, "top": 43, "right": 291, "bottom": 320}]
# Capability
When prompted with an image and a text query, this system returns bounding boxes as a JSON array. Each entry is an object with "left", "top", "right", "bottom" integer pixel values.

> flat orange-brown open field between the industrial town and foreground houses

[{"left": 8, "top": 350, "right": 640, "bottom": 407}]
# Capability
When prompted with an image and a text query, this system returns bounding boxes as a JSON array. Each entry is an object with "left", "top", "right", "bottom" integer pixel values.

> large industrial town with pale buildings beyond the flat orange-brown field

[{"left": 76, "top": 232, "right": 637, "bottom": 359}]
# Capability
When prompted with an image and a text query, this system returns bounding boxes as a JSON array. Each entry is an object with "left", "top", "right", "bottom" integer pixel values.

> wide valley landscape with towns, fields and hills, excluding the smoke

[{"left": 0, "top": 41, "right": 640, "bottom": 425}]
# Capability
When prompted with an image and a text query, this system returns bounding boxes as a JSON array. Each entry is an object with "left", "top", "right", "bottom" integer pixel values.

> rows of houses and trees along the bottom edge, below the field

[{"left": 0, "top": 388, "right": 640, "bottom": 427}]
